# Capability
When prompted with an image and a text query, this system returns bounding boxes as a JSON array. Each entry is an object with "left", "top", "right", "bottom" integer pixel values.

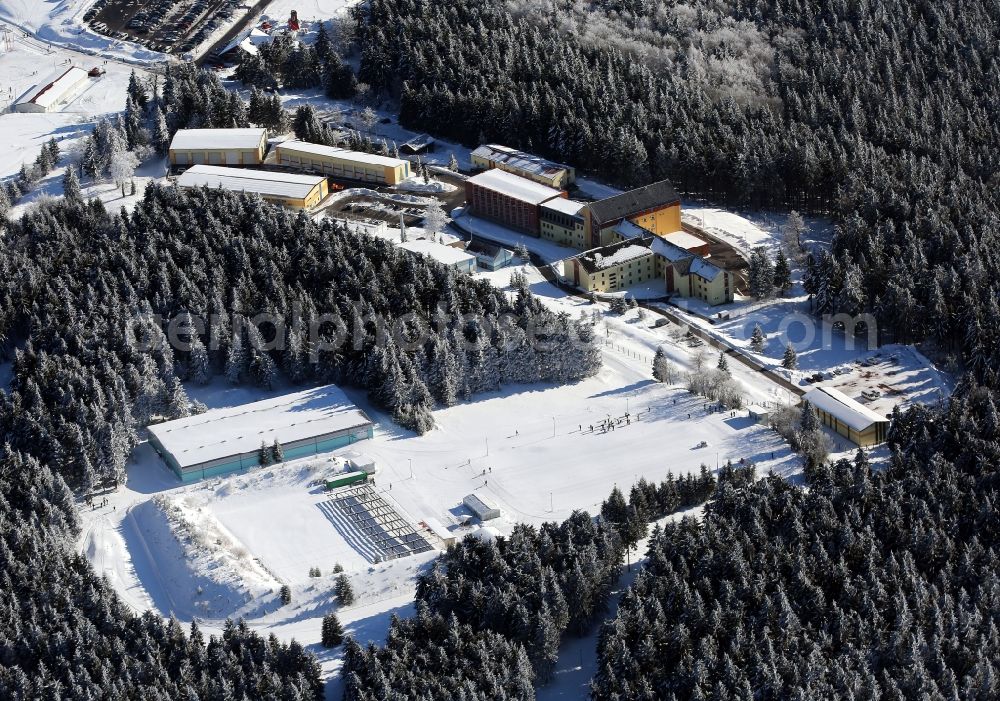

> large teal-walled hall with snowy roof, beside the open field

[{"left": 148, "top": 385, "right": 373, "bottom": 481}]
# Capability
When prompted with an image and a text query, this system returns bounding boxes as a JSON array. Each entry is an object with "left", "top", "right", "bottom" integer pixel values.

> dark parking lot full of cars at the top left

[{"left": 84, "top": 0, "right": 247, "bottom": 54}]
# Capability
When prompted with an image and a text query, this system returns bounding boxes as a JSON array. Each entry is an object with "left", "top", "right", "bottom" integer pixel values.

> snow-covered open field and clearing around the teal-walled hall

[{"left": 80, "top": 258, "right": 800, "bottom": 693}]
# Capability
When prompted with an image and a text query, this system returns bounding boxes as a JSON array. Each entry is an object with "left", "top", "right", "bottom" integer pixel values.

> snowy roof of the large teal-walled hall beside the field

[{"left": 149, "top": 385, "right": 372, "bottom": 468}]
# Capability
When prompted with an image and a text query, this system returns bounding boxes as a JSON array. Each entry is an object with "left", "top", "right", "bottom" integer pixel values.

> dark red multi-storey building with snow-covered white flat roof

[{"left": 465, "top": 168, "right": 565, "bottom": 237}]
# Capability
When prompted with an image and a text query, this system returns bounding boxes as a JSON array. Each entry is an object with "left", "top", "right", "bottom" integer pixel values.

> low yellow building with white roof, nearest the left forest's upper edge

[{"left": 177, "top": 165, "right": 329, "bottom": 209}]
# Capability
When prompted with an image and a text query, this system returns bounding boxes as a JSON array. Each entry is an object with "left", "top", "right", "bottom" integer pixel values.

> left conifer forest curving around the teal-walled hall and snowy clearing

[{"left": 0, "top": 186, "right": 600, "bottom": 700}]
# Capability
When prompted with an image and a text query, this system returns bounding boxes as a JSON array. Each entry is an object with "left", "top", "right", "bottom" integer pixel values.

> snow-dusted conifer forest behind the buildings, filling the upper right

[{"left": 356, "top": 0, "right": 1000, "bottom": 378}]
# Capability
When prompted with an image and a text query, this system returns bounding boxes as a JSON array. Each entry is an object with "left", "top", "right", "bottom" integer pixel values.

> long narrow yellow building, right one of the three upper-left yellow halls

[{"left": 274, "top": 141, "right": 410, "bottom": 185}]
